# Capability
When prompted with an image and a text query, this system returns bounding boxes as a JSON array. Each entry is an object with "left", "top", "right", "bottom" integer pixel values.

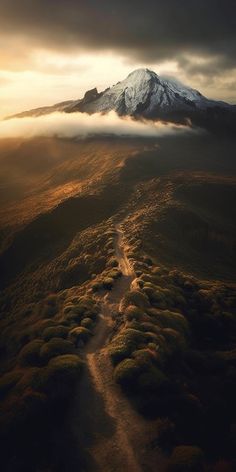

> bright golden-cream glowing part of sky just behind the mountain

[{"left": 0, "top": 49, "right": 235, "bottom": 118}]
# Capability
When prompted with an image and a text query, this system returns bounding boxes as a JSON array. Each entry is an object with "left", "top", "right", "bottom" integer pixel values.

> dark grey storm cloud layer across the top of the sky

[{"left": 0, "top": 0, "right": 236, "bottom": 69}]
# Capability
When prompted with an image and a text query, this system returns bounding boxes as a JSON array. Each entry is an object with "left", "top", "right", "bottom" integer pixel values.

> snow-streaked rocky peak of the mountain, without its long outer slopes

[{"left": 67, "top": 69, "right": 219, "bottom": 117}]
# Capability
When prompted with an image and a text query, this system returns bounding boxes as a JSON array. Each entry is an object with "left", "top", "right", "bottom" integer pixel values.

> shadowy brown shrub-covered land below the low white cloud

[{"left": 0, "top": 135, "right": 236, "bottom": 472}]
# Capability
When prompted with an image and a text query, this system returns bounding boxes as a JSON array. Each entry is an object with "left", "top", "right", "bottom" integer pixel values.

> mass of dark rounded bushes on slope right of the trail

[{"left": 108, "top": 260, "right": 236, "bottom": 472}]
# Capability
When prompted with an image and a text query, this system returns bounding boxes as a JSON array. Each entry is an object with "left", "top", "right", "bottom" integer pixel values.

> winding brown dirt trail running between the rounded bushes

[{"left": 70, "top": 225, "right": 166, "bottom": 472}]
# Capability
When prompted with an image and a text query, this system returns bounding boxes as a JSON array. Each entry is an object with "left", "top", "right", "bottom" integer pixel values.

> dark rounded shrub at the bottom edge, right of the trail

[{"left": 168, "top": 446, "right": 205, "bottom": 472}]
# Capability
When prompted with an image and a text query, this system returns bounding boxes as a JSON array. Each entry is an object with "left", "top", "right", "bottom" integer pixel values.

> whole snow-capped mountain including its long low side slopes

[{"left": 10, "top": 69, "right": 236, "bottom": 134}]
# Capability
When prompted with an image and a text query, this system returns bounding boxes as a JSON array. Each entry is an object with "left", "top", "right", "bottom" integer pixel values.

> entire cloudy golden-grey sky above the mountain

[{"left": 0, "top": 0, "right": 236, "bottom": 117}]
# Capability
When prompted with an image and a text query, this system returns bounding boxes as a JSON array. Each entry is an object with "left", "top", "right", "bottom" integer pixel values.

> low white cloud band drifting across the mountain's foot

[{"left": 0, "top": 112, "right": 193, "bottom": 139}]
